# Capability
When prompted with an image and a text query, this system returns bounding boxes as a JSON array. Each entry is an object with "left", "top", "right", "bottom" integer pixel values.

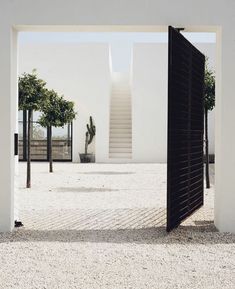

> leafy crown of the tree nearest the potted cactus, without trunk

[{"left": 38, "top": 90, "right": 76, "bottom": 127}]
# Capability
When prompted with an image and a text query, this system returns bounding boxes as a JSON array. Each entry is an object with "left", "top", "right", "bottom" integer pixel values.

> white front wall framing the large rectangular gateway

[{"left": 0, "top": 0, "right": 235, "bottom": 232}]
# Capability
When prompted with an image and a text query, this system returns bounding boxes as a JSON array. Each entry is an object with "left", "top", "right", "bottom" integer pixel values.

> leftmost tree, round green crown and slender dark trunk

[{"left": 18, "top": 70, "right": 47, "bottom": 188}]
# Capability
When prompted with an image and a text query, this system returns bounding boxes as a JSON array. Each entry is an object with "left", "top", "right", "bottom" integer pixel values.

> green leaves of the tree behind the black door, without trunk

[{"left": 204, "top": 58, "right": 215, "bottom": 111}]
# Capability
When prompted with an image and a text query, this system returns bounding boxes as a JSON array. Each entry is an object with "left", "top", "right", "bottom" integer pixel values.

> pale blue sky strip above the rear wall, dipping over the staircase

[{"left": 19, "top": 32, "right": 216, "bottom": 71}]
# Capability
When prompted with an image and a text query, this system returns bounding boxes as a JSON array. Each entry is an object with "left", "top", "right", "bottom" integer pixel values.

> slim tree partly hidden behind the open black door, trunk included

[{"left": 204, "top": 58, "right": 215, "bottom": 188}]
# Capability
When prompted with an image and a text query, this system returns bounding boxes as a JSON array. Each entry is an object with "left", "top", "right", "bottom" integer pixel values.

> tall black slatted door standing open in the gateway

[{"left": 167, "top": 27, "right": 205, "bottom": 232}]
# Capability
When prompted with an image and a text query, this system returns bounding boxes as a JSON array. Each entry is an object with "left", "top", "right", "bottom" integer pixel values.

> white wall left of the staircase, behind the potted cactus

[{"left": 19, "top": 43, "right": 110, "bottom": 162}]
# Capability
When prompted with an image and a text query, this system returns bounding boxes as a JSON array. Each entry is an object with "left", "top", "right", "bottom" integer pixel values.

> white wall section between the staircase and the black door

[{"left": 132, "top": 43, "right": 168, "bottom": 162}]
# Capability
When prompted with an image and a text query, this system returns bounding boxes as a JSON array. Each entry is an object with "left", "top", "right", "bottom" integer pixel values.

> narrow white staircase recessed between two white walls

[{"left": 109, "top": 72, "right": 132, "bottom": 162}]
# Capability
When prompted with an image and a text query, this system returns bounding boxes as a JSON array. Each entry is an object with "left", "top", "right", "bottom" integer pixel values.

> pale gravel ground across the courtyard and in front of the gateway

[{"left": 0, "top": 163, "right": 235, "bottom": 289}]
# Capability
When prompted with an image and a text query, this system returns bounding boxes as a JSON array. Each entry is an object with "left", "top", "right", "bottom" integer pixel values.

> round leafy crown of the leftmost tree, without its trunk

[{"left": 19, "top": 70, "right": 47, "bottom": 110}]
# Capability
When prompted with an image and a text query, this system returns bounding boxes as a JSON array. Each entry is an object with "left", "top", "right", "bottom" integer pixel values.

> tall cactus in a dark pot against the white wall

[{"left": 79, "top": 116, "right": 96, "bottom": 163}]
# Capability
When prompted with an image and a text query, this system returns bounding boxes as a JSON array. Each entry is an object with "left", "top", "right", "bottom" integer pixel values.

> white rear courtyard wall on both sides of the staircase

[{"left": 19, "top": 42, "right": 215, "bottom": 162}]
